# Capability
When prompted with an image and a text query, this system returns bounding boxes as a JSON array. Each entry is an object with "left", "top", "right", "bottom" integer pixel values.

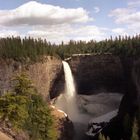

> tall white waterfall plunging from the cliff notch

[{"left": 62, "top": 61, "right": 78, "bottom": 120}]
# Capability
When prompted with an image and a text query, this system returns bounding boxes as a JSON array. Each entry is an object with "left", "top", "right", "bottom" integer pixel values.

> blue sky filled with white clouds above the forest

[{"left": 0, "top": 0, "right": 140, "bottom": 43}]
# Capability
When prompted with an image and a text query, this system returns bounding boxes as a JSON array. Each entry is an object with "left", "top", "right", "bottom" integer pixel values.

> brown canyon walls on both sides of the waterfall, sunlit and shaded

[{"left": 0, "top": 54, "right": 140, "bottom": 139}]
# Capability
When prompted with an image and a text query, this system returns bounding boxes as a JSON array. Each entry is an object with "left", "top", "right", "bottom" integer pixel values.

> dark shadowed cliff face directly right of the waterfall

[{"left": 68, "top": 54, "right": 125, "bottom": 94}]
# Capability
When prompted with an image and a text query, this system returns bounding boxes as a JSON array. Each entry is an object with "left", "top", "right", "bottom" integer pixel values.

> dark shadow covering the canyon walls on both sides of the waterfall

[{"left": 51, "top": 54, "right": 140, "bottom": 140}]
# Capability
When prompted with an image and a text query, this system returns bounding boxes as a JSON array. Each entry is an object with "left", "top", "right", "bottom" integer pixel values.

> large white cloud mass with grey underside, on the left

[{"left": 0, "top": 1, "right": 109, "bottom": 43}]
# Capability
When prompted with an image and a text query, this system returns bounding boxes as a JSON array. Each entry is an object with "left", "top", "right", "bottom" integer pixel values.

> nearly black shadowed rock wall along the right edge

[{"left": 94, "top": 57, "right": 140, "bottom": 140}]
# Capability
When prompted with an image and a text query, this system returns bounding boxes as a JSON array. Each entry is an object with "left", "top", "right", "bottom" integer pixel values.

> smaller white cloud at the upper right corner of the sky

[{"left": 109, "top": 0, "right": 140, "bottom": 35}]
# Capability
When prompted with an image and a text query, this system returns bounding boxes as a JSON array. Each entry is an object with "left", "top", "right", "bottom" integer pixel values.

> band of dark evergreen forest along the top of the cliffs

[{"left": 0, "top": 35, "right": 140, "bottom": 62}]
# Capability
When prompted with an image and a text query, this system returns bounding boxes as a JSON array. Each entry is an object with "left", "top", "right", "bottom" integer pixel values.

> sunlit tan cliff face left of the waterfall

[{"left": 0, "top": 57, "right": 62, "bottom": 99}]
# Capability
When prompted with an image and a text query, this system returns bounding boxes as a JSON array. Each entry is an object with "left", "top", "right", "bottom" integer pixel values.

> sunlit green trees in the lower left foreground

[{"left": 0, "top": 74, "right": 57, "bottom": 140}]
